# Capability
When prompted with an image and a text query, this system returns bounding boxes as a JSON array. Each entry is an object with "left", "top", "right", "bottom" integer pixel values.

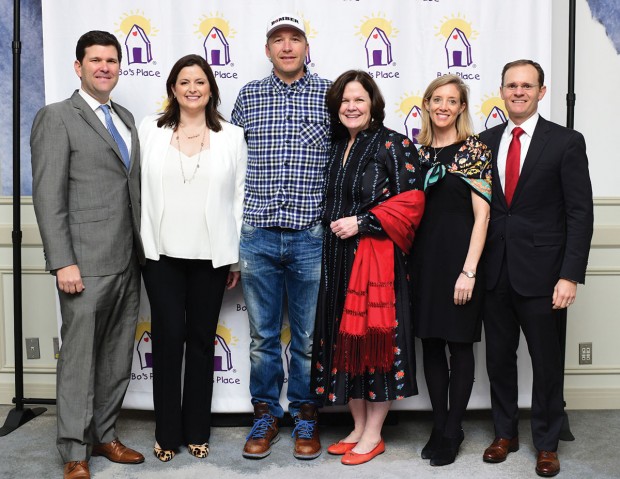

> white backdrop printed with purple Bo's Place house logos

[{"left": 42, "top": 0, "right": 553, "bottom": 412}]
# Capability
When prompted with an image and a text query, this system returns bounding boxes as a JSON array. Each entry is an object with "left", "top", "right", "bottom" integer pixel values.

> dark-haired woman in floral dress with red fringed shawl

[{"left": 312, "top": 71, "right": 424, "bottom": 464}]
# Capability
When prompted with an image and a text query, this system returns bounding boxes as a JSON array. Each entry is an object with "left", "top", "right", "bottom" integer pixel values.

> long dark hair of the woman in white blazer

[{"left": 157, "top": 55, "right": 224, "bottom": 131}]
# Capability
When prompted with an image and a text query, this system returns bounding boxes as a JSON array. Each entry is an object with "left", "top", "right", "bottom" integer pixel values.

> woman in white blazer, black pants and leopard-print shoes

[{"left": 139, "top": 55, "right": 247, "bottom": 461}]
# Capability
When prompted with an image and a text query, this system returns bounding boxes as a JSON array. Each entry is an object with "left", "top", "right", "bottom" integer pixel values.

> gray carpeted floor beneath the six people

[{"left": 0, "top": 406, "right": 620, "bottom": 479}]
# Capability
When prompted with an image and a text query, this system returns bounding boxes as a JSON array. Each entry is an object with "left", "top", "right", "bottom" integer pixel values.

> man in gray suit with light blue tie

[{"left": 30, "top": 31, "right": 144, "bottom": 479}]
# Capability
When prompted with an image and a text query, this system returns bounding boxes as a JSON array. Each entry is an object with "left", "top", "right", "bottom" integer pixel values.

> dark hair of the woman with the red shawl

[{"left": 325, "top": 70, "right": 385, "bottom": 140}]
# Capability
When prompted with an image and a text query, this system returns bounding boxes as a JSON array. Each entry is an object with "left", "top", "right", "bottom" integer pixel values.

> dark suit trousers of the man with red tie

[{"left": 484, "top": 263, "right": 564, "bottom": 451}]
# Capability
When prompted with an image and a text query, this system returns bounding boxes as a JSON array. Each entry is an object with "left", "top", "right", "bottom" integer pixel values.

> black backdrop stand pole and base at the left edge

[{"left": 0, "top": 0, "right": 46, "bottom": 436}]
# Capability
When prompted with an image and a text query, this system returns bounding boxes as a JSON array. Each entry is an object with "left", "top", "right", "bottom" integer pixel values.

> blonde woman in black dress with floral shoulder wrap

[{"left": 412, "top": 75, "right": 491, "bottom": 466}]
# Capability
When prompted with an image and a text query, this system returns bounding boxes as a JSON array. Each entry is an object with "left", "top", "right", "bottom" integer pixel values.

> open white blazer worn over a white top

[{"left": 138, "top": 115, "right": 248, "bottom": 271}]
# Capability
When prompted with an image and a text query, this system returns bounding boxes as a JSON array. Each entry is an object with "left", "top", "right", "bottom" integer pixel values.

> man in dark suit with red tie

[{"left": 480, "top": 60, "right": 593, "bottom": 476}]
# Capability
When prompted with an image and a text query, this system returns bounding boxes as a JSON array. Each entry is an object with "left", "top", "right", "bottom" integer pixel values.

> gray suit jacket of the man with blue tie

[{"left": 30, "top": 91, "right": 144, "bottom": 277}]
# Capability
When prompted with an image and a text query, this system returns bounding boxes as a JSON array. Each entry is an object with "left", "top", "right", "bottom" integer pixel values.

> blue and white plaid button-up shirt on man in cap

[{"left": 231, "top": 70, "right": 331, "bottom": 230}]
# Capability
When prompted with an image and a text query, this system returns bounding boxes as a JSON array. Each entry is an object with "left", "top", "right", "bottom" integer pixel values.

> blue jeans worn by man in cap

[{"left": 240, "top": 223, "right": 323, "bottom": 418}]
